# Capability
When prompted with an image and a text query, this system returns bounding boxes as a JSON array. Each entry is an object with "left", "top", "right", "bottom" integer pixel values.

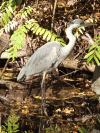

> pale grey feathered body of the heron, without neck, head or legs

[{"left": 17, "top": 41, "right": 74, "bottom": 80}]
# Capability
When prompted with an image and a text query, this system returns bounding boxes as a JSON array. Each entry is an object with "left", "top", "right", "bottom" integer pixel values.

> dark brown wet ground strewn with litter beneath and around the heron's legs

[{"left": 0, "top": 66, "right": 100, "bottom": 133}]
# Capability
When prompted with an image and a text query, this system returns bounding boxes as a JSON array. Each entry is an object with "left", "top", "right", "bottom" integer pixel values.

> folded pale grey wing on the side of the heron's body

[{"left": 25, "top": 42, "right": 60, "bottom": 76}]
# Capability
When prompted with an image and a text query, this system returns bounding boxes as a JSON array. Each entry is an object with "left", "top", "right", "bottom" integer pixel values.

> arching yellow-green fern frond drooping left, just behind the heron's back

[{"left": 7, "top": 19, "right": 66, "bottom": 60}]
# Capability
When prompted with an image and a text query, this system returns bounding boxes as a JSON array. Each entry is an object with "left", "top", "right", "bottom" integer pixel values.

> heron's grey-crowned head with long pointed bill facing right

[{"left": 68, "top": 19, "right": 94, "bottom": 29}]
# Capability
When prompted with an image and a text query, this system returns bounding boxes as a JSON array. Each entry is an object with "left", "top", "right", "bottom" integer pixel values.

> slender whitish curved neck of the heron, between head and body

[{"left": 62, "top": 26, "right": 76, "bottom": 56}]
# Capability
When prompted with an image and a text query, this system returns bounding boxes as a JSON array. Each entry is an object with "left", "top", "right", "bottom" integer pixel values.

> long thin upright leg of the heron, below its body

[{"left": 41, "top": 72, "right": 46, "bottom": 114}]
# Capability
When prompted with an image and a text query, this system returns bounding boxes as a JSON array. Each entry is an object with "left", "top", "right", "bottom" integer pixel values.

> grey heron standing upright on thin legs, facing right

[{"left": 17, "top": 19, "right": 92, "bottom": 113}]
